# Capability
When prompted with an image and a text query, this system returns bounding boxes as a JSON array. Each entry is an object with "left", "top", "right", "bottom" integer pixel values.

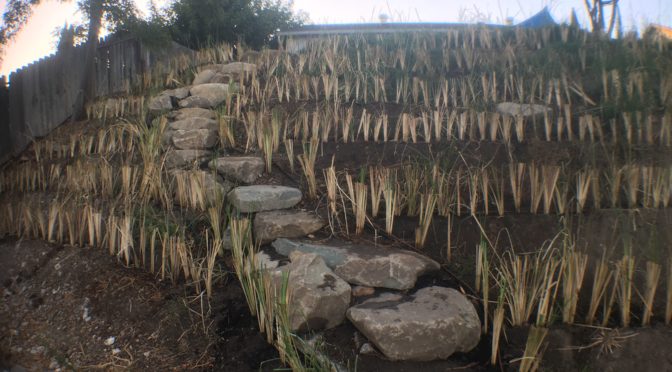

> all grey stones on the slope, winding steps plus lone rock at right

[{"left": 149, "top": 62, "right": 480, "bottom": 361}]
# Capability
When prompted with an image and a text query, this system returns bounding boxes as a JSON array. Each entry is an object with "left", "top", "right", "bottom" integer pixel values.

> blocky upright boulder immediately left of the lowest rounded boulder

[{"left": 272, "top": 254, "right": 350, "bottom": 332}]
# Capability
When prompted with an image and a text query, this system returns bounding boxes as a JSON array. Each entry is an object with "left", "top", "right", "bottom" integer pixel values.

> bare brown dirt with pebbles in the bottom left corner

[{"left": 0, "top": 240, "right": 276, "bottom": 371}]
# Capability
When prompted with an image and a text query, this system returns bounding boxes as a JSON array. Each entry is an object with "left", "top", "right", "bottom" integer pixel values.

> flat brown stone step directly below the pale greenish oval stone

[{"left": 254, "top": 210, "right": 324, "bottom": 244}]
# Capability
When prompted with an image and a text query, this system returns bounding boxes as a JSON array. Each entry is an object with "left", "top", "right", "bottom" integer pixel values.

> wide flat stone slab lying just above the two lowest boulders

[{"left": 273, "top": 238, "right": 440, "bottom": 290}]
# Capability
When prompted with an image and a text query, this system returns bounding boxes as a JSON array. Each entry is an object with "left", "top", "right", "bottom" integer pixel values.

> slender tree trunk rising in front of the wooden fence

[{"left": 72, "top": 0, "right": 103, "bottom": 120}]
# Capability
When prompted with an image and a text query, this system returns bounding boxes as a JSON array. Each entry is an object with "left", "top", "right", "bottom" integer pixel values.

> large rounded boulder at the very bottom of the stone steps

[{"left": 347, "top": 287, "right": 481, "bottom": 361}]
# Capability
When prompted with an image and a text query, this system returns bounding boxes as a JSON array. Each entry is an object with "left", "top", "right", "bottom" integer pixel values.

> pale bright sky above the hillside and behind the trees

[{"left": 0, "top": 0, "right": 672, "bottom": 75}]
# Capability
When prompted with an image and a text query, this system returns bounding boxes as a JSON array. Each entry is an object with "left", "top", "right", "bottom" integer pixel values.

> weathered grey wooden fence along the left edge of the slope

[{"left": 0, "top": 35, "right": 190, "bottom": 163}]
